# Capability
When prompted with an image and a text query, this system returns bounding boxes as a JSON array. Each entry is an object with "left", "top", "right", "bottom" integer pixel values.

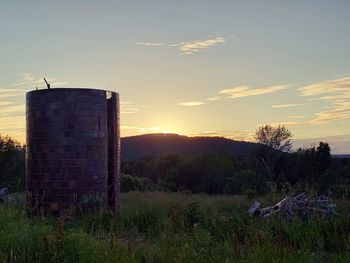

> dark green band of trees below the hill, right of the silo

[{"left": 122, "top": 142, "right": 350, "bottom": 198}]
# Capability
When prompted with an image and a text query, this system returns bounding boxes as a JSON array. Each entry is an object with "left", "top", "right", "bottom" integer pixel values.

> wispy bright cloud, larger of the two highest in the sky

[{"left": 169, "top": 36, "right": 226, "bottom": 55}]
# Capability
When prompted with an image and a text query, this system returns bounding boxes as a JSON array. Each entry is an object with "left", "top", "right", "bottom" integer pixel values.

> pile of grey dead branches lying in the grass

[{"left": 248, "top": 193, "right": 336, "bottom": 220}]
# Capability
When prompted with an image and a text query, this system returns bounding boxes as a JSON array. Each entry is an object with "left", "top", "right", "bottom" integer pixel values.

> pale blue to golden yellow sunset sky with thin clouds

[{"left": 0, "top": 0, "right": 350, "bottom": 153}]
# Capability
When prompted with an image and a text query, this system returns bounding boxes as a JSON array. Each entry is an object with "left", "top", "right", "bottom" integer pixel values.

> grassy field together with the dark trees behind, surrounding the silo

[{"left": 0, "top": 133, "right": 350, "bottom": 263}]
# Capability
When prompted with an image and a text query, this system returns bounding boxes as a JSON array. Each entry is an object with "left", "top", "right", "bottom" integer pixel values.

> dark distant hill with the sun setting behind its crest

[{"left": 121, "top": 134, "right": 258, "bottom": 160}]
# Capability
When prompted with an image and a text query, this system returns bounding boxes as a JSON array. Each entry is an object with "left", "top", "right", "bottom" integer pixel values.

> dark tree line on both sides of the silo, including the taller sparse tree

[{"left": 0, "top": 125, "right": 350, "bottom": 197}]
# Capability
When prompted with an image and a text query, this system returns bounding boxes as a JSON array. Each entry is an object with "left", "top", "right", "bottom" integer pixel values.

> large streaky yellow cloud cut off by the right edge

[{"left": 299, "top": 77, "right": 350, "bottom": 125}]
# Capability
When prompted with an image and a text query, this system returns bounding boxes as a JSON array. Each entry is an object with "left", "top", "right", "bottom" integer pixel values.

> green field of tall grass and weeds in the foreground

[{"left": 0, "top": 192, "right": 350, "bottom": 263}]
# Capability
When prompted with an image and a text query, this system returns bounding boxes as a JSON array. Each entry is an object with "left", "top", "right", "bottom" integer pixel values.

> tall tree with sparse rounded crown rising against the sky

[{"left": 255, "top": 125, "right": 293, "bottom": 179}]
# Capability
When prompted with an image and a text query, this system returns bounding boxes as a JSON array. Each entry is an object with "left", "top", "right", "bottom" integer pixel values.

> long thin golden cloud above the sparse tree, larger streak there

[{"left": 219, "top": 85, "right": 288, "bottom": 99}]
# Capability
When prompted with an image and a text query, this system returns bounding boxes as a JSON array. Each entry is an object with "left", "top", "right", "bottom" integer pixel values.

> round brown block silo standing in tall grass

[{"left": 26, "top": 88, "right": 120, "bottom": 215}]
